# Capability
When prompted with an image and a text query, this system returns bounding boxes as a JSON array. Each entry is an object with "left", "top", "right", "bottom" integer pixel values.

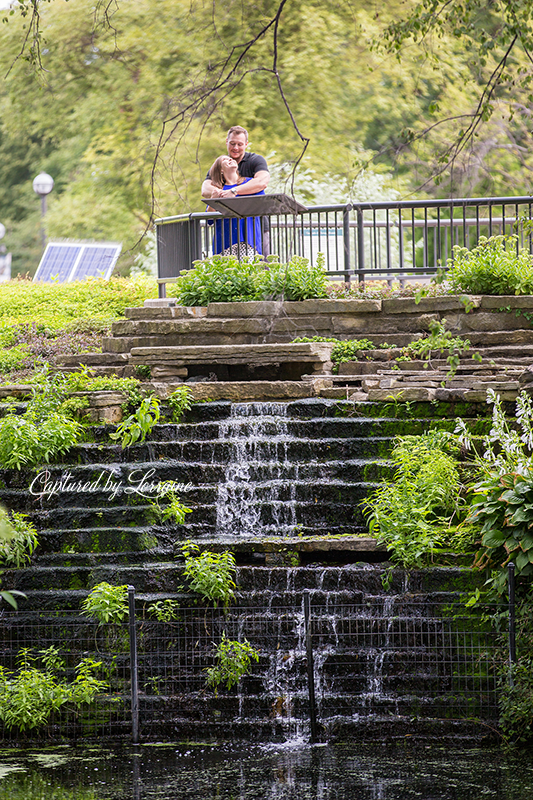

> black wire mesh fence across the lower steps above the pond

[{"left": 0, "top": 595, "right": 508, "bottom": 740}]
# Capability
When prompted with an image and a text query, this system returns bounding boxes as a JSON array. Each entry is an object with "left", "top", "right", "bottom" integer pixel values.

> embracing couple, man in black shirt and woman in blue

[{"left": 202, "top": 125, "right": 270, "bottom": 257}]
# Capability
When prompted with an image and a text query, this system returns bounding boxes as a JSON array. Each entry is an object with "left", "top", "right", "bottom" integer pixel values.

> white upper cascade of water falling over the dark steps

[{"left": 216, "top": 403, "right": 298, "bottom": 537}]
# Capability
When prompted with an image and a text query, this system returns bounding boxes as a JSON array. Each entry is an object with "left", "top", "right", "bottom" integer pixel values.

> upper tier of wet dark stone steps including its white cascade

[{"left": 0, "top": 398, "right": 485, "bottom": 608}]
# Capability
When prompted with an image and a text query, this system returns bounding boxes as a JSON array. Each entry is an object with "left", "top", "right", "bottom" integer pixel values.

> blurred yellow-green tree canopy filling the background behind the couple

[{"left": 0, "top": 0, "right": 533, "bottom": 271}]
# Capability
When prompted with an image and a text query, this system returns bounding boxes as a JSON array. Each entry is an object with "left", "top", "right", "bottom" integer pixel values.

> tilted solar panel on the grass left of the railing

[{"left": 33, "top": 242, "right": 122, "bottom": 283}]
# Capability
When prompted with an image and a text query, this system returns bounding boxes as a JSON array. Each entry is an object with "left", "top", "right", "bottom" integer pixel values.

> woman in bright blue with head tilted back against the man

[{"left": 207, "top": 156, "right": 265, "bottom": 256}]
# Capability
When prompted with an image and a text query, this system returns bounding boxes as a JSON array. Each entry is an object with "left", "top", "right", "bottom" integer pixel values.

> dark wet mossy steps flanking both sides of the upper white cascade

[{"left": 0, "top": 400, "right": 447, "bottom": 607}]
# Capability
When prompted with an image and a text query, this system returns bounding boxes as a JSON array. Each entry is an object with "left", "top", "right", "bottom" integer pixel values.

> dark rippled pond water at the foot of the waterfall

[{"left": 0, "top": 744, "right": 533, "bottom": 800}]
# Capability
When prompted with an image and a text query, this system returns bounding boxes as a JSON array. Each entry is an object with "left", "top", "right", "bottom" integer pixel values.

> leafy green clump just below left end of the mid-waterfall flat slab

[{"left": 180, "top": 541, "right": 235, "bottom": 608}]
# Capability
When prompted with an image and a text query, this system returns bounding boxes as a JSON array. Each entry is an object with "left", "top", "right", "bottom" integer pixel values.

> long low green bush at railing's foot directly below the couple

[{"left": 176, "top": 254, "right": 327, "bottom": 306}]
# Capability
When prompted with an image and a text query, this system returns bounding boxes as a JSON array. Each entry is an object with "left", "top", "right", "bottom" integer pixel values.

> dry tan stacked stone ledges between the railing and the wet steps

[{"left": 57, "top": 296, "right": 533, "bottom": 402}]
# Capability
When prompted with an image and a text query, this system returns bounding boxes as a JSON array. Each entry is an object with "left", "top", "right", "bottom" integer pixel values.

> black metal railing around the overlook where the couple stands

[{"left": 155, "top": 197, "right": 533, "bottom": 297}]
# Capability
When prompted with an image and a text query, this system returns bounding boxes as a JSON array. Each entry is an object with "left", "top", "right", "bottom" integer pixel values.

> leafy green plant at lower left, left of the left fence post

[{"left": 0, "top": 646, "right": 109, "bottom": 731}]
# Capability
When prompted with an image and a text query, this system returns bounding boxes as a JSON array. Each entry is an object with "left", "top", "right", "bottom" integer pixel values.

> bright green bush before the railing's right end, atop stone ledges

[{"left": 446, "top": 236, "right": 533, "bottom": 295}]
